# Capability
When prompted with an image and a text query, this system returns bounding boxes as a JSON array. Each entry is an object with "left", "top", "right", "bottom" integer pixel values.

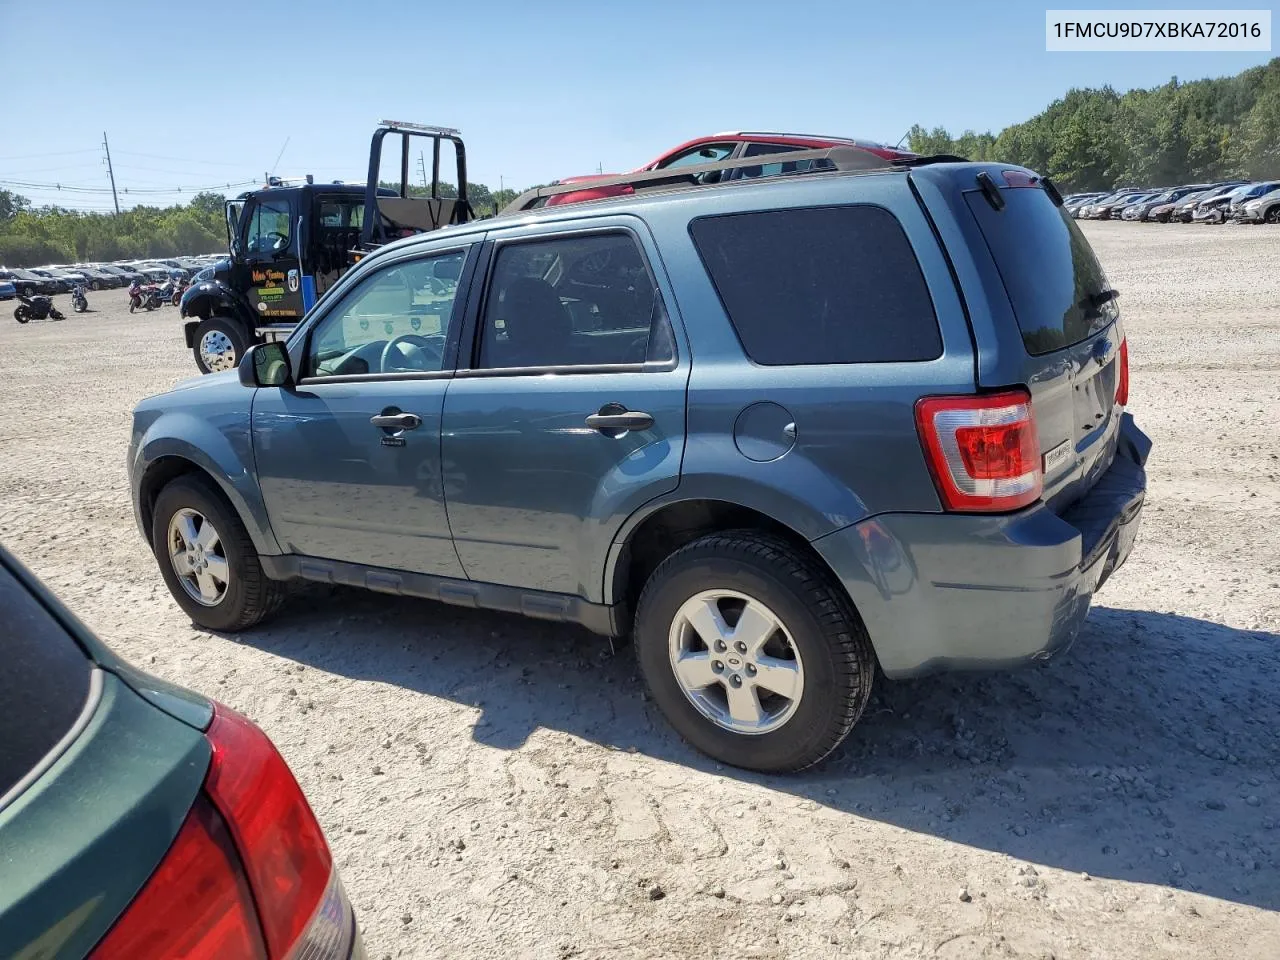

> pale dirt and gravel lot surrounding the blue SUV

[{"left": 0, "top": 224, "right": 1280, "bottom": 960}]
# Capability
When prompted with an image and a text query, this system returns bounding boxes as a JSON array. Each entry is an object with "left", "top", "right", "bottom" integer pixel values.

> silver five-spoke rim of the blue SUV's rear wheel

[{"left": 668, "top": 590, "right": 804, "bottom": 735}]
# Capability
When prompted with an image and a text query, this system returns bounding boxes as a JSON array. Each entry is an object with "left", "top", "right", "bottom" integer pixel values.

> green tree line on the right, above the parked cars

[{"left": 909, "top": 58, "right": 1280, "bottom": 191}]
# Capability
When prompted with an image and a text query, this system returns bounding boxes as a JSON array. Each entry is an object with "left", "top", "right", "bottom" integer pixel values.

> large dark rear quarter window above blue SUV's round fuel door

[{"left": 689, "top": 205, "right": 942, "bottom": 366}]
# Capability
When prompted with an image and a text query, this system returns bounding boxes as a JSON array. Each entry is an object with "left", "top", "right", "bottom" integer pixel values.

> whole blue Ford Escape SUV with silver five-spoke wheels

[{"left": 129, "top": 160, "right": 1149, "bottom": 771}]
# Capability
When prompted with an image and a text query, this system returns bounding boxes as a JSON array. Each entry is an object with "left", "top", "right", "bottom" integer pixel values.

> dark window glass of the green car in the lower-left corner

[{"left": 0, "top": 563, "right": 92, "bottom": 797}]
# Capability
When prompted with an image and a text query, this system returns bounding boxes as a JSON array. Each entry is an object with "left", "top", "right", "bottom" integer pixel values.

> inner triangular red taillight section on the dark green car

[{"left": 90, "top": 797, "right": 266, "bottom": 960}]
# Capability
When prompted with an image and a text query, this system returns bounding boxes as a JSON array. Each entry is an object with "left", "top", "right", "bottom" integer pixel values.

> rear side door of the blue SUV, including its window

[{"left": 442, "top": 225, "right": 690, "bottom": 602}]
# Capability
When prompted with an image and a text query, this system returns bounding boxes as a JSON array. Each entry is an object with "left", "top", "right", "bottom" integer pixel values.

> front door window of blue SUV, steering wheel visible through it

[{"left": 305, "top": 251, "right": 466, "bottom": 376}]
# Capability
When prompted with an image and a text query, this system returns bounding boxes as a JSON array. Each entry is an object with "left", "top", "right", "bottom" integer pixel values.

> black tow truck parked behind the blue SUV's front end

[{"left": 180, "top": 120, "right": 475, "bottom": 374}]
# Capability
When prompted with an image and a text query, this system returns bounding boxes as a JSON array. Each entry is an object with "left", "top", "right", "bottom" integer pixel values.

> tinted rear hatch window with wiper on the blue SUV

[{"left": 965, "top": 187, "right": 1116, "bottom": 356}]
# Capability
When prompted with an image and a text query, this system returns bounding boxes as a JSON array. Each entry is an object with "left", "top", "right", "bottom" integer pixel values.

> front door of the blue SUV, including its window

[{"left": 252, "top": 246, "right": 468, "bottom": 577}]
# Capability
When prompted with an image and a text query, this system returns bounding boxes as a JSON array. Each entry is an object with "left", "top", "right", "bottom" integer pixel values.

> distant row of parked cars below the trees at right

[{"left": 1064, "top": 180, "right": 1280, "bottom": 223}]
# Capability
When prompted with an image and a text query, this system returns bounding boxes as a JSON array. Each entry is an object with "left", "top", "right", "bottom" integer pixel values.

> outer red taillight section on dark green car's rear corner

[{"left": 205, "top": 704, "right": 333, "bottom": 957}]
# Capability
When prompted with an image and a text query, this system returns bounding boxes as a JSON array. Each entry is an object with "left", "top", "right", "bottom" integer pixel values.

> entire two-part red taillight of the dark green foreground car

[{"left": 92, "top": 704, "right": 356, "bottom": 960}]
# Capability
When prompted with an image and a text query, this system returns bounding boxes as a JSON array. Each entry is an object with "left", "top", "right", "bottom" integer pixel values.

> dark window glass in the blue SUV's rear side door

[{"left": 479, "top": 233, "right": 673, "bottom": 369}]
